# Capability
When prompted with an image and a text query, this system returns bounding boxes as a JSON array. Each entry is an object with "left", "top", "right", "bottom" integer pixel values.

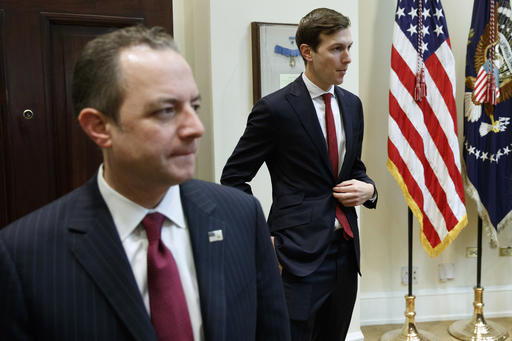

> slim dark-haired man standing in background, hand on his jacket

[{"left": 221, "top": 8, "right": 377, "bottom": 341}]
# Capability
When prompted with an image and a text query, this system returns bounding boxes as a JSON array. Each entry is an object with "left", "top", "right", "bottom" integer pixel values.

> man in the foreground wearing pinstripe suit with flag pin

[{"left": 0, "top": 26, "right": 289, "bottom": 341}]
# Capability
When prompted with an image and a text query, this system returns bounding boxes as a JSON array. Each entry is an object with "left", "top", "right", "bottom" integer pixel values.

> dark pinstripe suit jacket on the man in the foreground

[{"left": 0, "top": 177, "right": 289, "bottom": 341}]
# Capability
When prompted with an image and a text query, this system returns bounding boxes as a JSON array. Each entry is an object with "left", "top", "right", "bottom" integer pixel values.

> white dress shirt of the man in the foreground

[{"left": 98, "top": 165, "right": 204, "bottom": 341}]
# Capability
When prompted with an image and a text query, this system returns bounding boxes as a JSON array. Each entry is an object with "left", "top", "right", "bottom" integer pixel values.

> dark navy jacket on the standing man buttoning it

[{"left": 221, "top": 76, "right": 377, "bottom": 276}]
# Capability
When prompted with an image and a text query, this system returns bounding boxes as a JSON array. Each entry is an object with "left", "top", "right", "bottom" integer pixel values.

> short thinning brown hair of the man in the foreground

[{"left": 72, "top": 25, "right": 178, "bottom": 123}]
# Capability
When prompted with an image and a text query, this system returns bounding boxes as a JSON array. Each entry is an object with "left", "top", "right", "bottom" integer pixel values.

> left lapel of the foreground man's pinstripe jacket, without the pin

[{"left": 68, "top": 177, "right": 156, "bottom": 341}]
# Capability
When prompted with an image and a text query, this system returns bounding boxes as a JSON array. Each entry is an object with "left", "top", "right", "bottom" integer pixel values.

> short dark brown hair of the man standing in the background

[{"left": 295, "top": 8, "right": 350, "bottom": 61}]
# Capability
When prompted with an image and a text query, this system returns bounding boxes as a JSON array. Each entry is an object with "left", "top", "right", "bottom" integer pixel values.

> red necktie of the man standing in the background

[{"left": 322, "top": 93, "right": 354, "bottom": 238}]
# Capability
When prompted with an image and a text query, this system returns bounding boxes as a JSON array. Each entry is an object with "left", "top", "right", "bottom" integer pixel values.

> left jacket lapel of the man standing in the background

[{"left": 286, "top": 76, "right": 331, "bottom": 173}]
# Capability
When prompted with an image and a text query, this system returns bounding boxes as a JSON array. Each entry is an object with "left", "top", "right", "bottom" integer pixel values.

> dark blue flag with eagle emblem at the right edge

[{"left": 463, "top": 0, "right": 512, "bottom": 246}]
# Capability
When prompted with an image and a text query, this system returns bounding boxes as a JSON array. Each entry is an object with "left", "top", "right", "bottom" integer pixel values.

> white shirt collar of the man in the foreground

[{"left": 97, "top": 164, "right": 186, "bottom": 241}]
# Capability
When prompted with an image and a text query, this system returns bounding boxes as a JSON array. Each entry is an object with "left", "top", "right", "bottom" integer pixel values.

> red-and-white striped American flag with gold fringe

[{"left": 387, "top": 0, "right": 467, "bottom": 257}]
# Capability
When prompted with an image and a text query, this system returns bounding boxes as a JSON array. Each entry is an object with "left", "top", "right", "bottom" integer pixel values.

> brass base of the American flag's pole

[{"left": 380, "top": 296, "right": 437, "bottom": 341}]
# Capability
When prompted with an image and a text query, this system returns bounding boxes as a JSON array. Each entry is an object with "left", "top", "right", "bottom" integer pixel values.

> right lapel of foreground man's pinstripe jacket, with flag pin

[{"left": 180, "top": 180, "right": 229, "bottom": 341}]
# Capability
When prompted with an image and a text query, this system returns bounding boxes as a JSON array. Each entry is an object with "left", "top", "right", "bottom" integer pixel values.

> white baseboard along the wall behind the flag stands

[{"left": 358, "top": 285, "right": 512, "bottom": 326}]
